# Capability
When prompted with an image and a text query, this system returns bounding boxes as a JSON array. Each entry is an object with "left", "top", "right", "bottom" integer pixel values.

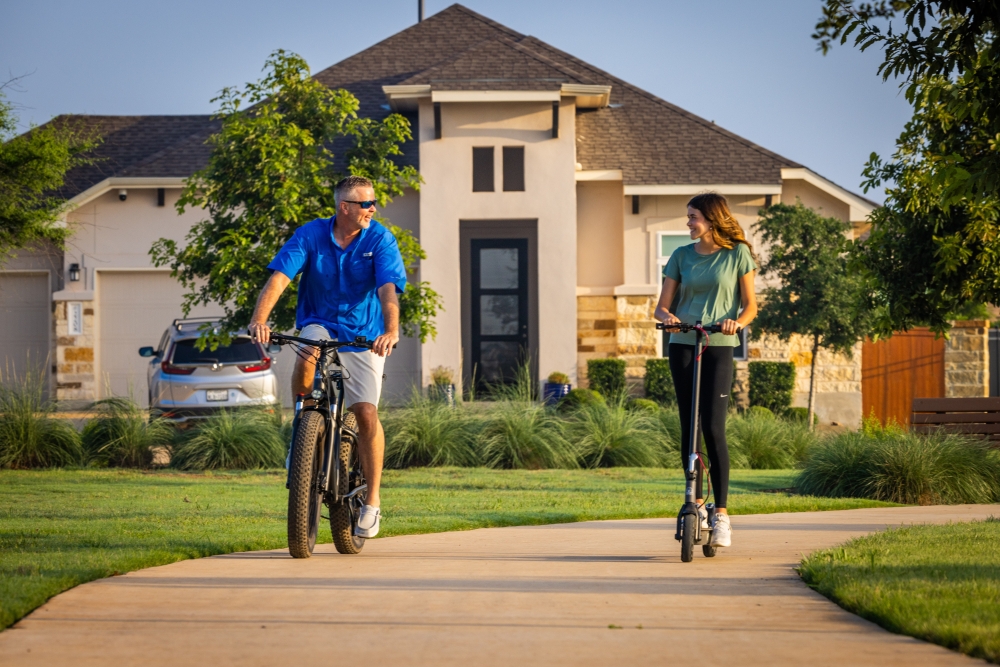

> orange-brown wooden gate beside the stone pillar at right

[{"left": 861, "top": 329, "right": 944, "bottom": 425}]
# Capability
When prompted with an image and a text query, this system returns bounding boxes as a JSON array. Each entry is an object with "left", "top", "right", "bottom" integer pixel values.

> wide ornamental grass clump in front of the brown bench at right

[{"left": 797, "top": 424, "right": 1000, "bottom": 505}]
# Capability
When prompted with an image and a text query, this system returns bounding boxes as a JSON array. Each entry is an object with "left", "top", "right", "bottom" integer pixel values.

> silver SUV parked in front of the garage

[{"left": 139, "top": 318, "right": 278, "bottom": 422}]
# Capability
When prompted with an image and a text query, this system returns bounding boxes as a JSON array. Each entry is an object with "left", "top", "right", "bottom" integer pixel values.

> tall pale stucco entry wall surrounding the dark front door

[{"left": 418, "top": 98, "right": 577, "bottom": 392}]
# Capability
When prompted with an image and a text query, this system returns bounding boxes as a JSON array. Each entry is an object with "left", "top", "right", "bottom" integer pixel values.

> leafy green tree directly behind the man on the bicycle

[{"left": 150, "top": 50, "right": 441, "bottom": 347}]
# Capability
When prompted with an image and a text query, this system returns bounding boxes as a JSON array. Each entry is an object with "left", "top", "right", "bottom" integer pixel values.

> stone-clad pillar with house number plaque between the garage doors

[{"left": 53, "top": 301, "right": 97, "bottom": 407}]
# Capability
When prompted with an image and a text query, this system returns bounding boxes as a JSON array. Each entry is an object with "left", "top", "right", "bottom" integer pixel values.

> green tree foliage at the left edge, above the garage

[{"left": 0, "top": 79, "right": 98, "bottom": 263}]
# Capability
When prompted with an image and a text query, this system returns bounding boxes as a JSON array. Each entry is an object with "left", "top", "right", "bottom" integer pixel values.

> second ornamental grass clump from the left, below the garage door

[{"left": 83, "top": 398, "right": 174, "bottom": 468}]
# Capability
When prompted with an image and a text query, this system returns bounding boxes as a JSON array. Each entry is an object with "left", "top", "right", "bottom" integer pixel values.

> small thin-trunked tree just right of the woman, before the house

[{"left": 753, "top": 203, "right": 868, "bottom": 429}]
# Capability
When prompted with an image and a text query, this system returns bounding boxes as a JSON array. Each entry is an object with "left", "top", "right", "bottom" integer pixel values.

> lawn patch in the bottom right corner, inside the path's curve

[{"left": 801, "top": 519, "right": 1000, "bottom": 663}]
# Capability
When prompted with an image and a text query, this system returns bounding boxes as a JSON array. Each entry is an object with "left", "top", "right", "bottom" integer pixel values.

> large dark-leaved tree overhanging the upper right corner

[{"left": 813, "top": 0, "right": 1000, "bottom": 335}]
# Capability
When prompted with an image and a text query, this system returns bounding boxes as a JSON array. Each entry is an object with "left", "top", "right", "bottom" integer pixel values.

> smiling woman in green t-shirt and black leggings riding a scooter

[{"left": 654, "top": 192, "right": 758, "bottom": 547}]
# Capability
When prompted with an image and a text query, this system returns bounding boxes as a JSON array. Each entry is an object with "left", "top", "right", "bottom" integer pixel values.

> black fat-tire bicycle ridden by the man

[{"left": 271, "top": 333, "right": 372, "bottom": 558}]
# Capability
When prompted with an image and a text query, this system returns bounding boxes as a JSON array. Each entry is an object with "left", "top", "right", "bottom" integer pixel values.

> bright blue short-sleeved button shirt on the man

[{"left": 267, "top": 218, "right": 406, "bottom": 352}]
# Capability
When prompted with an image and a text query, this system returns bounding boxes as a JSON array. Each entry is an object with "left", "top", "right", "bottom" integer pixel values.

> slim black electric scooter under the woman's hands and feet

[{"left": 656, "top": 322, "right": 722, "bottom": 563}]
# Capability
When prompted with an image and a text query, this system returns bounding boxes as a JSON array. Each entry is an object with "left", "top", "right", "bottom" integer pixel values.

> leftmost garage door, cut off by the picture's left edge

[{"left": 0, "top": 272, "right": 52, "bottom": 394}]
